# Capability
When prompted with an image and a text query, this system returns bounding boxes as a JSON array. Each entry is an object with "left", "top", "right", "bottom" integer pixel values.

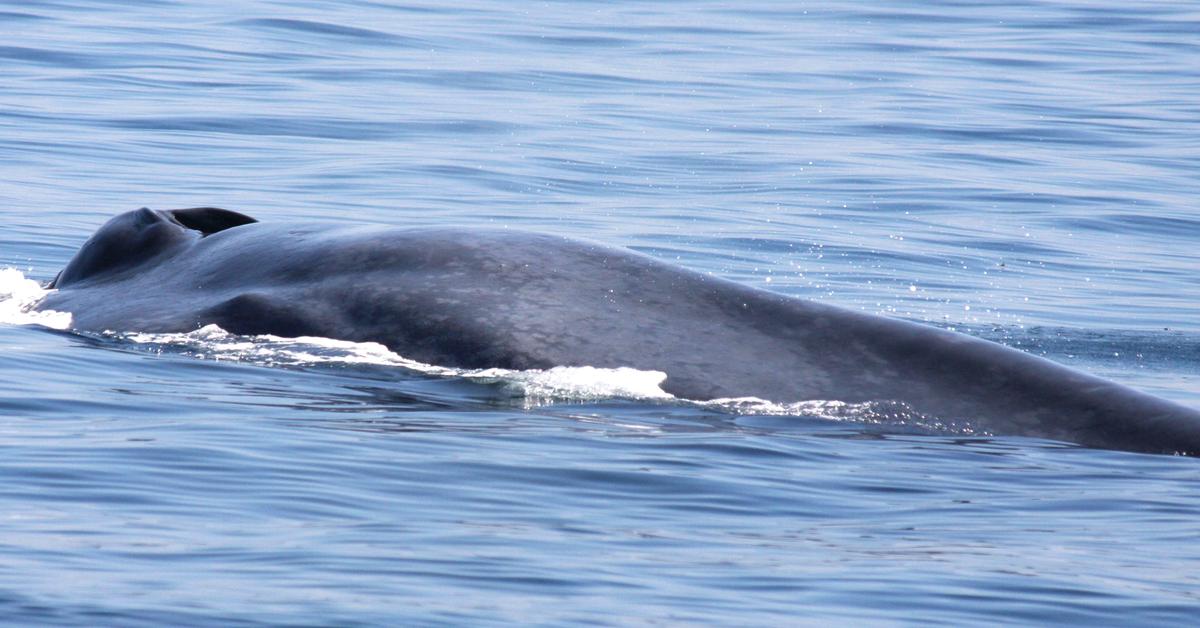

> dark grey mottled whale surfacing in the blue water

[{"left": 38, "top": 208, "right": 1200, "bottom": 455}]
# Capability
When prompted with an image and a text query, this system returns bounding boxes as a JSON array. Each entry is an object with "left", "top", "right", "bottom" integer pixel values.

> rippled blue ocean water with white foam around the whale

[{"left": 0, "top": 0, "right": 1200, "bottom": 626}]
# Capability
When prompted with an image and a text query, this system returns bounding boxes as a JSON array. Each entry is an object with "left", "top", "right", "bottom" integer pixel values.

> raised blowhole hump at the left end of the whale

[{"left": 47, "top": 208, "right": 257, "bottom": 288}]
